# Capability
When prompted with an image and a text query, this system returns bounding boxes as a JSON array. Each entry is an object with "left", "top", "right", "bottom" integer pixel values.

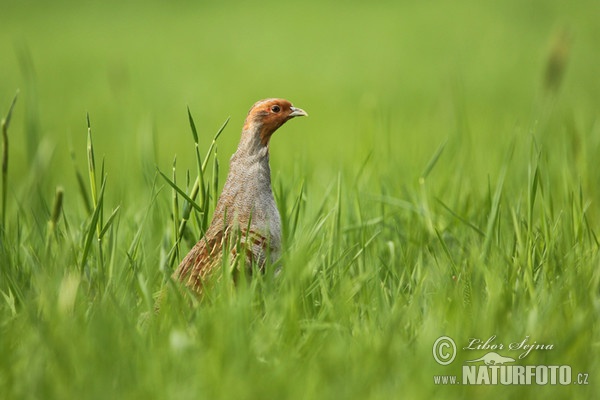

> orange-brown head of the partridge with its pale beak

[{"left": 244, "top": 99, "right": 308, "bottom": 146}]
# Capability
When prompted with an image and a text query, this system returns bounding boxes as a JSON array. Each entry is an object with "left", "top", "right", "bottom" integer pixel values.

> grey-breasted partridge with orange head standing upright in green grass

[{"left": 173, "top": 98, "right": 308, "bottom": 294}]
